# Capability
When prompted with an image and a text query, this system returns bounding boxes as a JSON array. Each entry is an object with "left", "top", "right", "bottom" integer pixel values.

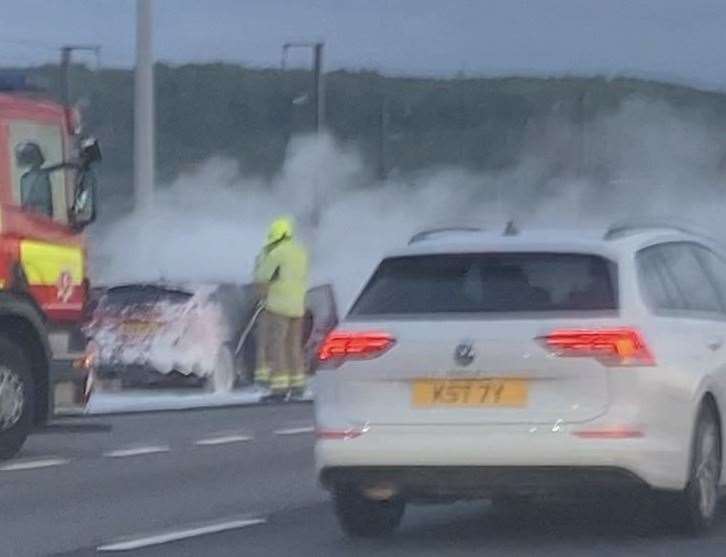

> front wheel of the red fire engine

[{"left": 0, "top": 336, "right": 35, "bottom": 460}]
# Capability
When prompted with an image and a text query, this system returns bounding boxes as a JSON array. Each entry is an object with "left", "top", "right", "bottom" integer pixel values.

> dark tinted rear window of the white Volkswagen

[{"left": 351, "top": 252, "right": 617, "bottom": 316}]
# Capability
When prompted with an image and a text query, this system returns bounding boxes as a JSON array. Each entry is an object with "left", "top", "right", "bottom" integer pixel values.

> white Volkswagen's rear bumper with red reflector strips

[{"left": 315, "top": 426, "right": 688, "bottom": 490}]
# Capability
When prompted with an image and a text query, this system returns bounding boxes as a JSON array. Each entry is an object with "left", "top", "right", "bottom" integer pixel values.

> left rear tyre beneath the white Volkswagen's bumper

[{"left": 333, "top": 486, "right": 406, "bottom": 538}]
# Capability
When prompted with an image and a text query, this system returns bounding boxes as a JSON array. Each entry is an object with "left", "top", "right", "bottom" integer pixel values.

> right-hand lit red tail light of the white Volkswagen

[{"left": 543, "top": 327, "right": 655, "bottom": 366}]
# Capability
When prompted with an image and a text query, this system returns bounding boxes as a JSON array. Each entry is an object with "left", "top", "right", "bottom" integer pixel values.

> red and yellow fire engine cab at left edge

[{"left": 0, "top": 76, "right": 101, "bottom": 459}]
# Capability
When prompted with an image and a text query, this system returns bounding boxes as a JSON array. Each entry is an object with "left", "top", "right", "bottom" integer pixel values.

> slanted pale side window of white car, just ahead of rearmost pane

[{"left": 658, "top": 242, "right": 723, "bottom": 313}]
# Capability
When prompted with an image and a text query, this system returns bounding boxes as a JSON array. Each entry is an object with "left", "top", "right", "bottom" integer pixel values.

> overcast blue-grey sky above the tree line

[{"left": 0, "top": 0, "right": 726, "bottom": 89}]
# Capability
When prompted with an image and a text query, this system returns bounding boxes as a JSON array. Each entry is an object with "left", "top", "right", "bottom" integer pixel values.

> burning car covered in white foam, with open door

[{"left": 84, "top": 283, "right": 337, "bottom": 393}]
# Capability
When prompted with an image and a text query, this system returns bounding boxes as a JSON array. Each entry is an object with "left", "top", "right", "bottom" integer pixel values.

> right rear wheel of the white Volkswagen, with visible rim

[{"left": 661, "top": 402, "right": 723, "bottom": 535}]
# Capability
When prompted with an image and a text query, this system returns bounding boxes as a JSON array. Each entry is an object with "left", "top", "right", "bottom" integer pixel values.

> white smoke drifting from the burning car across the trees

[{"left": 92, "top": 97, "right": 726, "bottom": 309}]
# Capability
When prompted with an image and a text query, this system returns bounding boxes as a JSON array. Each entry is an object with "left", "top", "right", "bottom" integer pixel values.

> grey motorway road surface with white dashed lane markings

[{"left": 0, "top": 404, "right": 726, "bottom": 557}]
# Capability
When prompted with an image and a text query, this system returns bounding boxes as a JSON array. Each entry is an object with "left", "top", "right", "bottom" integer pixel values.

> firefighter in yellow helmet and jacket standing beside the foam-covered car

[{"left": 255, "top": 217, "right": 308, "bottom": 399}]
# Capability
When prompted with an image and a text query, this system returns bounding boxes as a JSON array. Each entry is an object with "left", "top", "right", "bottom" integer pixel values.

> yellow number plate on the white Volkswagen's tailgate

[{"left": 412, "top": 379, "right": 528, "bottom": 407}]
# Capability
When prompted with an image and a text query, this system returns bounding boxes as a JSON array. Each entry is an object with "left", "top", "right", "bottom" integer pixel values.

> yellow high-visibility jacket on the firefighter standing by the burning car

[{"left": 255, "top": 239, "right": 308, "bottom": 317}]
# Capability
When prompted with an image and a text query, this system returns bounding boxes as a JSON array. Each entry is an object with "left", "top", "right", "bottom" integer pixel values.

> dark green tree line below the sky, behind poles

[{"left": 17, "top": 63, "right": 726, "bottom": 200}]
